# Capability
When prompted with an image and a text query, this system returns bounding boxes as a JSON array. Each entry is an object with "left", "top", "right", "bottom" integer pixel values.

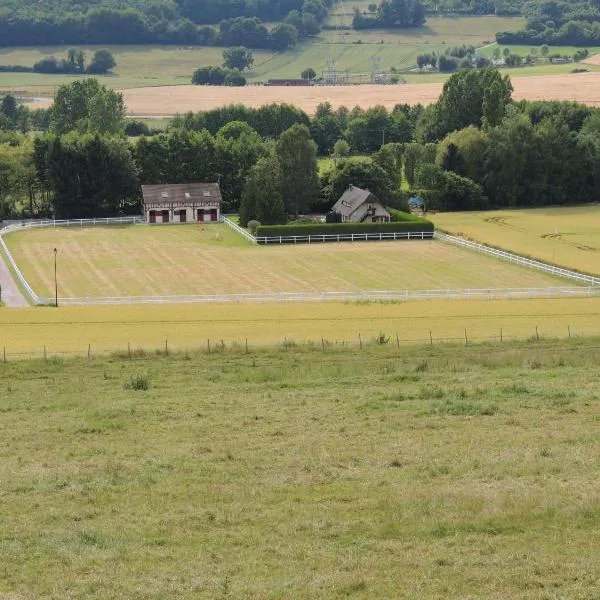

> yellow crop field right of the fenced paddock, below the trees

[{"left": 430, "top": 205, "right": 600, "bottom": 275}]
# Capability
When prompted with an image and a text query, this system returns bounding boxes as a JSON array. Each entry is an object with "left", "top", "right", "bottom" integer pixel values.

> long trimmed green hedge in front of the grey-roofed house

[{"left": 256, "top": 218, "right": 433, "bottom": 237}]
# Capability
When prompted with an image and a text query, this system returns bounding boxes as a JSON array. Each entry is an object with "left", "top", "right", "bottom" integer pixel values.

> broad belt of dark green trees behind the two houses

[{"left": 0, "top": 68, "right": 600, "bottom": 224}]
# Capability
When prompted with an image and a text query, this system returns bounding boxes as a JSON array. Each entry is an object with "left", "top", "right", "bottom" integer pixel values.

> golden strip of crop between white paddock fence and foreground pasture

[{"left": 0, "top": 298, "right": 600, "bottom": 361}]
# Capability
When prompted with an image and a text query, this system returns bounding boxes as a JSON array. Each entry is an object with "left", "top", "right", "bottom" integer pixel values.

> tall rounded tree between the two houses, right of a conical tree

[{"left": 276, "top": 123, "right": 319, "bottom": 216}]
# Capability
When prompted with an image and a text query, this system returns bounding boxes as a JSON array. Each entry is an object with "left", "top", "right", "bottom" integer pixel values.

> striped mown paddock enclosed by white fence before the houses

[{"left": 5, "top": 225, "right": 564, "bottom": 298}]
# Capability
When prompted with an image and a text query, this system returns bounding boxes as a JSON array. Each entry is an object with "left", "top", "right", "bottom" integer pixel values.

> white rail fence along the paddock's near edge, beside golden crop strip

[{"left": 40, "top": 287, "right": 600, "bottom": 306}]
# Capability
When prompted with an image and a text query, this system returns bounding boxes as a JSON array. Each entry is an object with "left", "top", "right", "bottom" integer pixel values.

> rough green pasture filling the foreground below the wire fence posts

[{"left": 0, "top": 338, "right": 600, "bottom": 600}]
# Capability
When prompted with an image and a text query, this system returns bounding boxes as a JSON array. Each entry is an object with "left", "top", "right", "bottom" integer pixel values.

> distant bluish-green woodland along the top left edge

[{"left": 0, "top": 0, "right": 328, "bottom": 50}]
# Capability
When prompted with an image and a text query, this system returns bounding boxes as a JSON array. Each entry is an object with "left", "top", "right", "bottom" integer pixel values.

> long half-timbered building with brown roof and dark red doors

[{"left": 142, "top": 183, "right": 221, "bottom": 223}]
